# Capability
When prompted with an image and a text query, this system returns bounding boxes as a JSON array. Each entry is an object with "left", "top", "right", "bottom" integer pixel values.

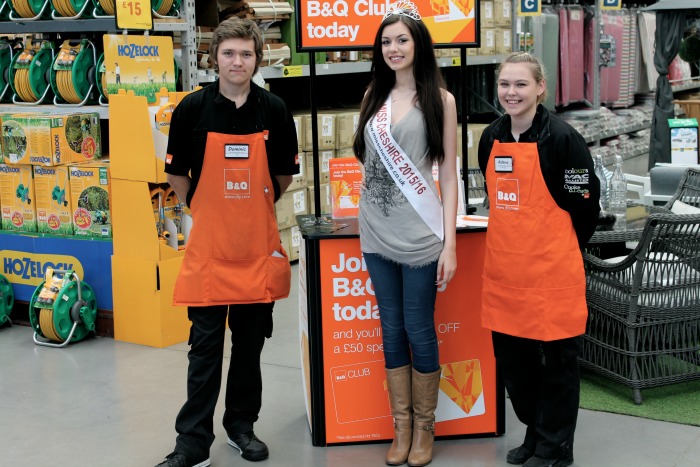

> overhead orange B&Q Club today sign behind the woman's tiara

[{"left": 295, "top": 0, "right": 479, "bottom": 52}]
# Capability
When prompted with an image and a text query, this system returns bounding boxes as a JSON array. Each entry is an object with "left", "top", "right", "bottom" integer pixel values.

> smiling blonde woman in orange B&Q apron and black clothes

[{"left": 479, "top": 52, "right": 600, "bottom": 467}]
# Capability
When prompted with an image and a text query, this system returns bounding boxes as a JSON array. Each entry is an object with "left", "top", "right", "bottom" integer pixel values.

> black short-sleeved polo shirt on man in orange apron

[{"left": 165, "top": 80, "right": 299, "bottom": 206}]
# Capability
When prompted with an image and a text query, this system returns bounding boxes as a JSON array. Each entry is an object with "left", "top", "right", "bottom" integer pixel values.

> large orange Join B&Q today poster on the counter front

[{"left": 319, "top": 232, "right": 498, "bottom": 444}]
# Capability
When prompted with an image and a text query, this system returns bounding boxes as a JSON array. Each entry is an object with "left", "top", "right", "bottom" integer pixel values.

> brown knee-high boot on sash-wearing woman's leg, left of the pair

[{"left": 386, "top": 365, "right": 413, "bottom": 465}]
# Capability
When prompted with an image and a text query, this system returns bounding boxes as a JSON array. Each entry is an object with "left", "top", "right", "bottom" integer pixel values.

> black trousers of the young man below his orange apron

[{"left": 175, "top": 303, "right": 274, "bottom": 459}]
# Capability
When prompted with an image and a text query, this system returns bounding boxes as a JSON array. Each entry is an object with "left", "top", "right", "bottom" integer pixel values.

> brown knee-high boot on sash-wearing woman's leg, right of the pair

[{"left": 408, "top": 368, "right": 441, "bottom": 467}]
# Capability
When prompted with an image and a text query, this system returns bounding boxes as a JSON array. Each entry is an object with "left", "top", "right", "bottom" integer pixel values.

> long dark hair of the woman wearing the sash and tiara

[{"left": 352, "top": 15, "right": 445, "bottom": 163}]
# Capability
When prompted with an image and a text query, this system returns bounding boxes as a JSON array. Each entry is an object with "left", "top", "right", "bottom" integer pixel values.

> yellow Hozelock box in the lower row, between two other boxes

[{"left": 33, "top": 166, "right": 73, "bottom": 235}]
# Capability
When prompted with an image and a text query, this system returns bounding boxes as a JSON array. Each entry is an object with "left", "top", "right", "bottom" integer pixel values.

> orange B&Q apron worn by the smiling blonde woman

[{"left": 481, "top": 141, "right": 588, "bottom": 341}]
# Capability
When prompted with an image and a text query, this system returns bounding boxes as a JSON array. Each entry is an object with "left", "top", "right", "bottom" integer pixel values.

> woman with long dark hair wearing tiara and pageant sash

[{"left": 353, "top": 1, "right": 457, "bottom": 466}]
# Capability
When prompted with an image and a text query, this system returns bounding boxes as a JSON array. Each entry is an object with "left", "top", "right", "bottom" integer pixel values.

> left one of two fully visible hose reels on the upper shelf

[{"left": 10, "top": 40, "right": 54, "bottom": 105}]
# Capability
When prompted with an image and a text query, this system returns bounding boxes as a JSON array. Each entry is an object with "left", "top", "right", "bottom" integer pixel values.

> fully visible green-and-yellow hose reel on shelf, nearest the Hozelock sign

[{"left": 51, "top": 39, "right": 97, "bottom": 106}]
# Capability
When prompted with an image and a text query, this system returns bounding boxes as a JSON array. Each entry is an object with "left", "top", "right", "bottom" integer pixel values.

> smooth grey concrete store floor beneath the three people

[{"left": 0, "top": 266, "right": 700, "bottom": 467}]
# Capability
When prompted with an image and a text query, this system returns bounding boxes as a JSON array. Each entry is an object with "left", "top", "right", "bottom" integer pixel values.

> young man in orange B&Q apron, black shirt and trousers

[{"left": 158, "top": 18, "right": 299, "bottom": 467}]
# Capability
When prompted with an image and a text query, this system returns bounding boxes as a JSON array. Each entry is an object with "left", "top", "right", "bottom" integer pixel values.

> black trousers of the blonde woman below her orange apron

[{"left": 492, "top": 332, "right": 582, "bottom": 458}]
